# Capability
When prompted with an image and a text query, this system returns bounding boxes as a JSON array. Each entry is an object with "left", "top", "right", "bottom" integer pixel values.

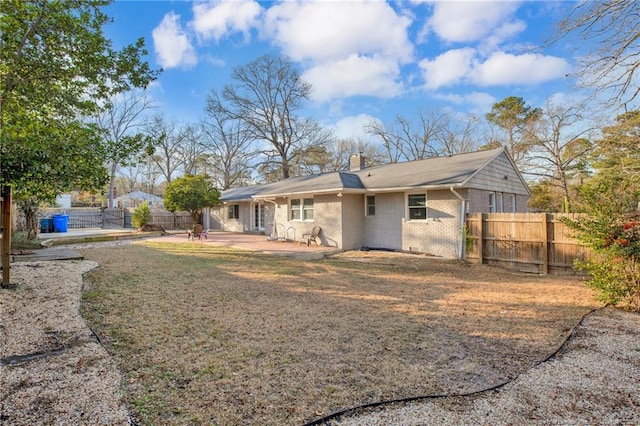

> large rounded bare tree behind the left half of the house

[{"left": 209, "top": 55, "right": 328, "bottom": 179}]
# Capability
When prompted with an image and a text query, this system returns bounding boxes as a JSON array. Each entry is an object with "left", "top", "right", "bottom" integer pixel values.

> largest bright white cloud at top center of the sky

[{"left": 263, "top": 0, "right": 413, "bottom": 62}]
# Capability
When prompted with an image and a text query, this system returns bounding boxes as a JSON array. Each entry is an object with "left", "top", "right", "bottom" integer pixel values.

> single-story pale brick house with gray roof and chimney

[{"left": 211, "top": 148, "right": 531, "bottom": 258}]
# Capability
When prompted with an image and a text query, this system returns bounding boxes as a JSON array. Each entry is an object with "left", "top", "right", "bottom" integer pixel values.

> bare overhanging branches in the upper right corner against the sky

[{"left": 550, "top": 0, "right": 640, "bottom": 106}]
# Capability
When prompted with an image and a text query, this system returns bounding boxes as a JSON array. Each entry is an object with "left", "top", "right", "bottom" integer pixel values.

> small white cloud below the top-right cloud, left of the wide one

[{"left": 419, "top": 47, "right": 476, "bottom": 89}]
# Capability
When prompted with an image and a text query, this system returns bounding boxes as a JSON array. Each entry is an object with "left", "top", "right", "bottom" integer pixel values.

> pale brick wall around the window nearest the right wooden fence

[{"left": 402, "top": 191, "right": 461, "bottom": 258}]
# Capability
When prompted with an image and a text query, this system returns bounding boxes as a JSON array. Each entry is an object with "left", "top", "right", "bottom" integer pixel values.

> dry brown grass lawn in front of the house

[{"left": 82, "top": 242, "right": 597, "bottom": 425}]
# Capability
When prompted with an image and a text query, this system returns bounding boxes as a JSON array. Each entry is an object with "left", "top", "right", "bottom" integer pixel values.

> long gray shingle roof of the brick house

[{"left": 220, "top": 148, "right": 504, "bottom": 201}]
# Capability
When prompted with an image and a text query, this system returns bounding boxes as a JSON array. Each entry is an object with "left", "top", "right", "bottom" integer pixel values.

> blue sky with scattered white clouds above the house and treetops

[{"left": 105, "top": 0, "right": 576, "bottom": 138}]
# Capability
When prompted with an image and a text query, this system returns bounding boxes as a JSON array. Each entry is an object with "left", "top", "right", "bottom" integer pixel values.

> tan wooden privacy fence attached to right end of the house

[{"left": 466, "top": 213, "right": 589, "bottom": 274}]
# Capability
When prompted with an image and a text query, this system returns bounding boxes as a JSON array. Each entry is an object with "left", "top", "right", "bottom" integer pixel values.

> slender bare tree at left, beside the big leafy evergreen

[{"left": 95, "top": 91, "right": 153, "bottom": 208}]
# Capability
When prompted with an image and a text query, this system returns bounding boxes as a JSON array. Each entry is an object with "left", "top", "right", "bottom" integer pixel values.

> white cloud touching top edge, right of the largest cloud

[{"left": 427, "top": 1, "right": 522, "bottom": 42}]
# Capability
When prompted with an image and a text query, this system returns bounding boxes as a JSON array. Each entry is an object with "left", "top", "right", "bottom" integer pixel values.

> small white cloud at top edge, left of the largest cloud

[{"left": 191, "top": 0, "right": 262, "bottom": 42}]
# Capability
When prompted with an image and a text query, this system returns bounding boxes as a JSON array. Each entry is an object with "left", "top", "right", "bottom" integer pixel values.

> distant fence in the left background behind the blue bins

[{"left": 40, "top": 207, "right": 193, "bottom": 229}]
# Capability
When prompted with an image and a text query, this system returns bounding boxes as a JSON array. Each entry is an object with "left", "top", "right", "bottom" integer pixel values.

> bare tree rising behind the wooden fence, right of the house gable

[{"left": 523, "top": 101, "right": 595, "bottom": 212}]
